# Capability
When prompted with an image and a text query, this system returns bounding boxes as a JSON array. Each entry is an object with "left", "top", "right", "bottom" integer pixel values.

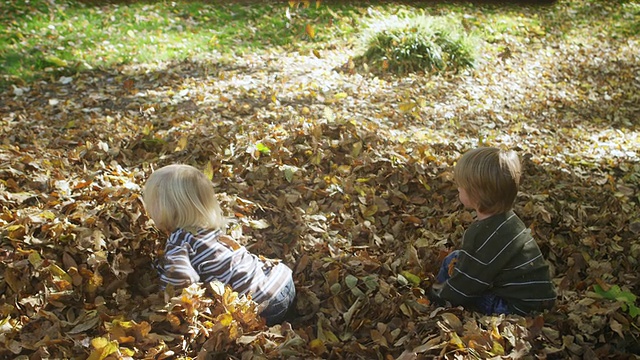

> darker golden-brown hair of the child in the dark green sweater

[{"left": 454, "top": 147, "right": 522, "bottom": 214}]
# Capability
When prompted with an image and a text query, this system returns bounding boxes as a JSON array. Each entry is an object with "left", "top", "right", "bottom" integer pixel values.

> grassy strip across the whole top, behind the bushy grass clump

[{"left": 0, "top": 0, "right": 640, "bottom": 89}]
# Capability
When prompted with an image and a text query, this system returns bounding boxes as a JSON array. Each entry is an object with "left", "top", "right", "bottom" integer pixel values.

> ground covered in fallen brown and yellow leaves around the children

[{"left": 0, "top": 1, "right": 640, "bottom": 359}]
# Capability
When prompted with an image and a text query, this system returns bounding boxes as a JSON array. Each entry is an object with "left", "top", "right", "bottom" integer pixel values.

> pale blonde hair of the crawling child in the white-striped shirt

[{"left": 143, "top": 164, "right": 225, "bottom": 232}]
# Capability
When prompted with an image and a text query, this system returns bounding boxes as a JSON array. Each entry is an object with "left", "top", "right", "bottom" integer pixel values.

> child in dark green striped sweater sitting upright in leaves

[{"left": 430, "top": 147, "right": 556, "bottom": 315}]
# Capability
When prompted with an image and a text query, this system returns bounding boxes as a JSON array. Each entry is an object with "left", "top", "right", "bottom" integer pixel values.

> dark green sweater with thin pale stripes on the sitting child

[{"left": 438, "top": 211, "right": 556, "bottom": 315}]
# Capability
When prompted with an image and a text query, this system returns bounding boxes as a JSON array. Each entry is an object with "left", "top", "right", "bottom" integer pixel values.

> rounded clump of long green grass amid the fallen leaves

[{"left": 356, "top": 15, "right": 478, "bottom": 74}]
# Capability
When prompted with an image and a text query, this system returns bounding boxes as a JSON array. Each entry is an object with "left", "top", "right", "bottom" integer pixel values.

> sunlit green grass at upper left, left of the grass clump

[{"left": 0, "top": 0, "right": 354, "bottom": 85}]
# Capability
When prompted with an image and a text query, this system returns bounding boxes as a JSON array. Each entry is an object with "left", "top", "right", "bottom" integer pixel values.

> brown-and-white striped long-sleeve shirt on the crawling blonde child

[{"left": 158, "top": 229, "right": 292, "bottom": 303}]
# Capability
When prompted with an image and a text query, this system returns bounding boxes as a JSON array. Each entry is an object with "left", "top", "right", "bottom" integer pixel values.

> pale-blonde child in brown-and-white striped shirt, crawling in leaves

[{"left": 143, "top": 164, "right": 295, "bottom": 326}]
